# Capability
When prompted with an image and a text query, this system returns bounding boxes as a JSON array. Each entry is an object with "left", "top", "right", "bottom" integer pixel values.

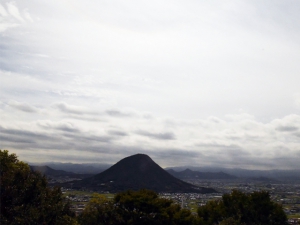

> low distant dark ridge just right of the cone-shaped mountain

[{"left": 166, "top": 169, "right": 237, "bottom": 180}]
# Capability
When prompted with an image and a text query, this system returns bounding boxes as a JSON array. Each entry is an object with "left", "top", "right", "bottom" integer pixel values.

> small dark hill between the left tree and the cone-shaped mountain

[{"left": 30, "top": 166, "right": 92, "bottom": 179}]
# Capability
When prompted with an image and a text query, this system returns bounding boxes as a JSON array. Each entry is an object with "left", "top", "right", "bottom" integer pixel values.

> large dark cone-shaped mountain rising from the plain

[{"left": 71, "top": 154, "right": 216, "bottom": 193}]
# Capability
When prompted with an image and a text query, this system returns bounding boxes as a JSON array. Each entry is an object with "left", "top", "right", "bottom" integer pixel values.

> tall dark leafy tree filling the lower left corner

[{"left": 0, "top": 150, "right": 76, "bottom": 225}]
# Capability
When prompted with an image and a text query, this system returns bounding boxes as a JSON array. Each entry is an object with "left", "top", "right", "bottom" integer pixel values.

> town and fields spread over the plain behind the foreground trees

[{"left": 63, "top": 179, "right": 300, "bottom": 224}]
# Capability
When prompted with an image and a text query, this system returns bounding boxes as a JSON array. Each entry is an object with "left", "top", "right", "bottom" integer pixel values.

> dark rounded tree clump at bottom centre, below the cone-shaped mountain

[{"left": 79, "top": 189, "right": 196, "bottom": 225}]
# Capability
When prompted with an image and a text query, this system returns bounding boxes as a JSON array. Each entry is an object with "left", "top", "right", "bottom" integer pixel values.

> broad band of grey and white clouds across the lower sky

[{"left": 0, "top": 98, "right": 300, "bottom": 169}]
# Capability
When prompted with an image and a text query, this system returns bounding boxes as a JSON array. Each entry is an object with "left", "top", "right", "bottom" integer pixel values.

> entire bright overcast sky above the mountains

[{"left": 0, "top": 0, "right": 300, "bottom": 169}]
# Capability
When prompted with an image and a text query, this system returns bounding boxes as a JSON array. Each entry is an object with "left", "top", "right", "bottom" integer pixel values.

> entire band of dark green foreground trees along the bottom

[{"left": 0, "top": 150, "right": 287, "bottom": 225}]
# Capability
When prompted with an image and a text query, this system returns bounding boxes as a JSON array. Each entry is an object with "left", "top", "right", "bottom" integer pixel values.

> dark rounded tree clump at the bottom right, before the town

[{"left": 198, "top": 190, "right": 287, "bottom": 225}]
